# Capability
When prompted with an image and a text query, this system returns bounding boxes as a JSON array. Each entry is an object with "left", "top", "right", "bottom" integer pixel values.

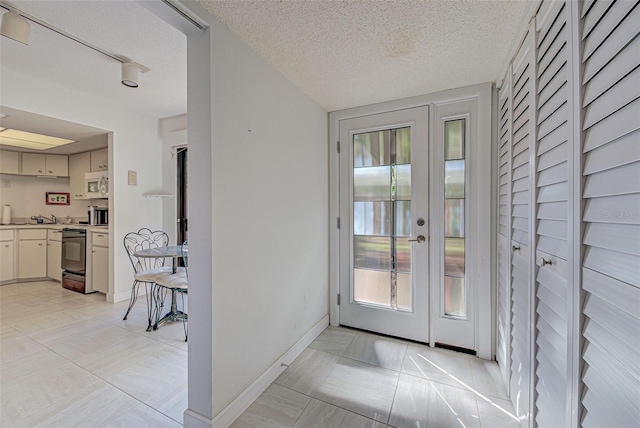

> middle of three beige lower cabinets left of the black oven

[{"left": 18, "top": 229, "right": 47, "bottom": 279}]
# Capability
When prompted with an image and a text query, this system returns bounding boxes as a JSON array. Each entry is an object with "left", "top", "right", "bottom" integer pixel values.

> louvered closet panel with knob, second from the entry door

[{"left": 509, "top": 33, "right": 533, "bottom": 418}]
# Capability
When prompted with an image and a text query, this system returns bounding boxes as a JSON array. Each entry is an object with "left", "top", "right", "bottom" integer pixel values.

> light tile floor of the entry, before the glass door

[{"left": 232, "top": 327, "right": 520, "bottom": 428}]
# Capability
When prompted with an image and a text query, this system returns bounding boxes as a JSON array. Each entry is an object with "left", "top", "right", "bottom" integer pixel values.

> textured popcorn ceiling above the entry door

[{"left": 200, "top": 0, "right": 530, "bottom": 111}]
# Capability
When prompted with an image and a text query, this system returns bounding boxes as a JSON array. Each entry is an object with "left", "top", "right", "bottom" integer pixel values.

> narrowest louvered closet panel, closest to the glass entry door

[{"left": 496, "top": 77, "right": 511, "bottom": 385}]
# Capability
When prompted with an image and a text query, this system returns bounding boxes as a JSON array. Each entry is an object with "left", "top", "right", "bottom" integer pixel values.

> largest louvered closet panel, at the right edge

[{"left": 581, "top": 1, "right": 640, "bottom": 427}]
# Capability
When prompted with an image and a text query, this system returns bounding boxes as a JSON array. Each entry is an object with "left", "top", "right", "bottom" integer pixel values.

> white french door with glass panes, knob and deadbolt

[{"left": 339, "top": 107, "right": 430, "bottom": 342}]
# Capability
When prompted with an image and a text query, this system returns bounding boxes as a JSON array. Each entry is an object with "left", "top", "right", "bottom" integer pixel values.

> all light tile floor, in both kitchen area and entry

[{"left": 0, "top": 281, "right": 520, "bottom": 428}]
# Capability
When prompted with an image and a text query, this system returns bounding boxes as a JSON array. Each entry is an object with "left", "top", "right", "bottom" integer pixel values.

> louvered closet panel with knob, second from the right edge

[{"left": 534, "top": 1, "right": 570, "bottom": 427}]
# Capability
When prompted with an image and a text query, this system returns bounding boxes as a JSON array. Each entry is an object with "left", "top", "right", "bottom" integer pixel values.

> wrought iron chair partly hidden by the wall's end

[{"left": 154, "top": 241, "right": 189, "bottom": 342}]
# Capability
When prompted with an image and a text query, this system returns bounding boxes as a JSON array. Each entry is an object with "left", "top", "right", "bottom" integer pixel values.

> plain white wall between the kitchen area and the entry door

[{"left": 182, "top": 3, "right": 329, "bottom": 418}]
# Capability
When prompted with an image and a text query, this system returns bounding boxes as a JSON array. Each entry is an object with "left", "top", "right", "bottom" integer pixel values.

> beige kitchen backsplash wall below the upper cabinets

[{"left": 0, "top": 174, "right": 108, "bottom": 222}]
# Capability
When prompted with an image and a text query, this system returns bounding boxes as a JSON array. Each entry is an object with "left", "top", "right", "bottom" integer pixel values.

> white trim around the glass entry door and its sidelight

[{"left": 329, "top": 83, "right": 496, "bottom": 359}]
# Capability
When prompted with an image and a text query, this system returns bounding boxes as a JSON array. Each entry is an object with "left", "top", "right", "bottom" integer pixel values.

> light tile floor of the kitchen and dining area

[{"left": 0, "top": 281, "right": 187, "bottom": 427}]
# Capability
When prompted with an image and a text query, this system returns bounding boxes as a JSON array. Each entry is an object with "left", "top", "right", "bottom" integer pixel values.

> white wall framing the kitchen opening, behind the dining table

[{"left": 0, "top": 68, "right": 168, "bottom": 301}]
